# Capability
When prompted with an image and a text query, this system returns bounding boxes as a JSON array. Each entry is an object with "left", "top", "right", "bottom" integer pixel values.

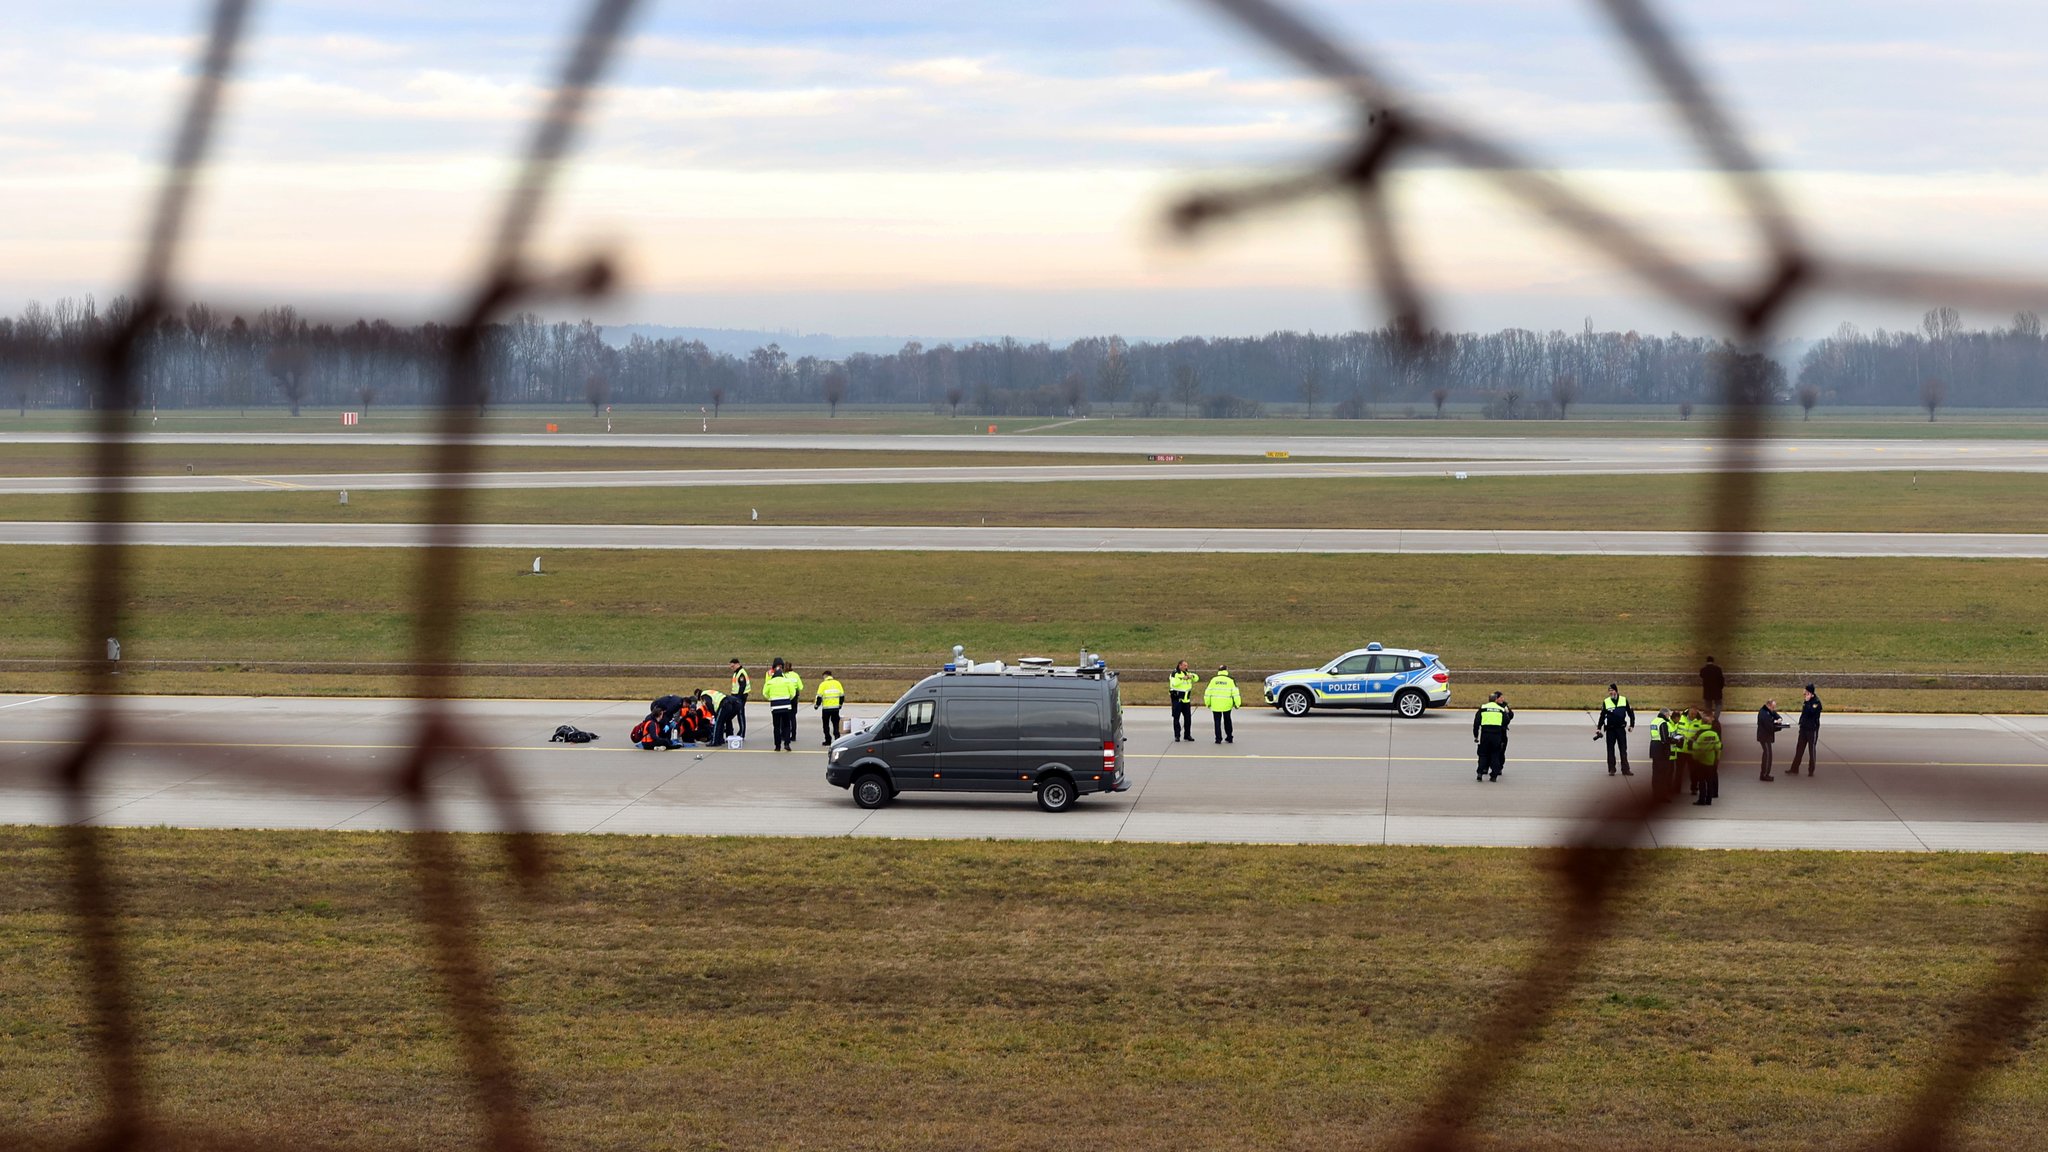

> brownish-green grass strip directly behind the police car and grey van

[{"left": 0, "top": 547, "right": 2048, "bottom": 703}]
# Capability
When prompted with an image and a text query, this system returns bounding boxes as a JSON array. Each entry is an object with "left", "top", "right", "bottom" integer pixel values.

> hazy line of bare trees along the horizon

[{"left": 0, "top": 297, "right": 2048, "bottom": 418}]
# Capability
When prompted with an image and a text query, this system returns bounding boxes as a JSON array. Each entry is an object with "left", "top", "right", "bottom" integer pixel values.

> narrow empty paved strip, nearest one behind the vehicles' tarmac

[{"left": 0, "top": 521, "right": 2048, "bottom": 560}]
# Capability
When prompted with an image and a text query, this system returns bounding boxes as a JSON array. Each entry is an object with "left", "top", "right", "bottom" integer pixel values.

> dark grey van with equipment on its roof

[{"left": 825, "top": 656, "right": 1130, "bottom": 812}]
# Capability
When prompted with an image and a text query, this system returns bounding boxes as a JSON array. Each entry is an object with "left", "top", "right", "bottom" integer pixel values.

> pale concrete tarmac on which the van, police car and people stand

[{"left": 0, "top": 685, "right": 2048, "bottom": 853}]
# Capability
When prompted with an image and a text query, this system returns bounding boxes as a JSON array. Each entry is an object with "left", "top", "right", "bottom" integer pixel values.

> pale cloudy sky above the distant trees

[{"left": 12, "top": 0, "right": 2048, "bottom": 340}]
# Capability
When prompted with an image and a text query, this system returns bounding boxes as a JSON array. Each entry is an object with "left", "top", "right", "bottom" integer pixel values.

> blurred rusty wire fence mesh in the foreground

[{"left": 12, "top": 0, "right": 2048, "bottom": 1152}]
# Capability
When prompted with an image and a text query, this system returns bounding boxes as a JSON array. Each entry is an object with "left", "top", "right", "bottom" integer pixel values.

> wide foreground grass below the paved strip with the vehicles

[{"left": 0, "top": 828, "right": 2048, "bottom": 1152}]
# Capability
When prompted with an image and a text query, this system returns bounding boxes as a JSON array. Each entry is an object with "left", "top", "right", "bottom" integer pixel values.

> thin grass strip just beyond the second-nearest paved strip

[{"left": 0, "top": 469, "right": 2048, "bottom": 533}]
